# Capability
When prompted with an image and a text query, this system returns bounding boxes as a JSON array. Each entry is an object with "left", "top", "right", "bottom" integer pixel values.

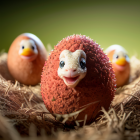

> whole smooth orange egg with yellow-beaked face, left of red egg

[{"left": 7, "top": 33, "right": 47, "bottom": 85}]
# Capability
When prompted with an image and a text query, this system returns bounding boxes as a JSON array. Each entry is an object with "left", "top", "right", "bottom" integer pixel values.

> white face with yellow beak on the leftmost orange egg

[{"left": 19, "top": 39, "right": 38, "bottom": 61}]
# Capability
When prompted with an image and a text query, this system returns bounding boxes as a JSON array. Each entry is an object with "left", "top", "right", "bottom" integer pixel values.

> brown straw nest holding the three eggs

[{"left": 0, "top": 53, "right": 140, "bottom": 140}]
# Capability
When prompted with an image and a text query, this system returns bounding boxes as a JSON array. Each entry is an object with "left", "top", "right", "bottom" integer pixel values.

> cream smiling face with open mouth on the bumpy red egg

[{"left": 57, "top": 50, "right": 87, "bottom": 87}]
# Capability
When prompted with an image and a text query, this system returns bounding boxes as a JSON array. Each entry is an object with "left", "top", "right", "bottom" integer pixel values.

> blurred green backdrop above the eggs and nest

[{"left": 0, "top": 0, "right": 140, "bottom": 58}]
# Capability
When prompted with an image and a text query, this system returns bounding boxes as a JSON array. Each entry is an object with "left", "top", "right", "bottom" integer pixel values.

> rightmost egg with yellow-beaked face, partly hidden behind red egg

[{"left": 105, "top": 45, "right": 130, "bottom": 87}]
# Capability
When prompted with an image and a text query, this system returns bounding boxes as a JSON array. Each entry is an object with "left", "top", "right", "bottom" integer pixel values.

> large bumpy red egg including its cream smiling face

[{"left": 41, "top": 35, "right": 116, "bottom": 124}]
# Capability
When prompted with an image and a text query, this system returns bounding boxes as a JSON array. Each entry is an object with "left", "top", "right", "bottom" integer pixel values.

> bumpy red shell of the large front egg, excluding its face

[{"left": 41, "top": 35, "right": 116, "bottom": 124}]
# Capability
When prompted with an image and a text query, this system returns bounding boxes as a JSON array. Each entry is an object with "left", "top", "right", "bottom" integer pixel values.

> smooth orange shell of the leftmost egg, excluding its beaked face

[{"left": 7, "top": 33, "right": 47, "bottom": 85}]
